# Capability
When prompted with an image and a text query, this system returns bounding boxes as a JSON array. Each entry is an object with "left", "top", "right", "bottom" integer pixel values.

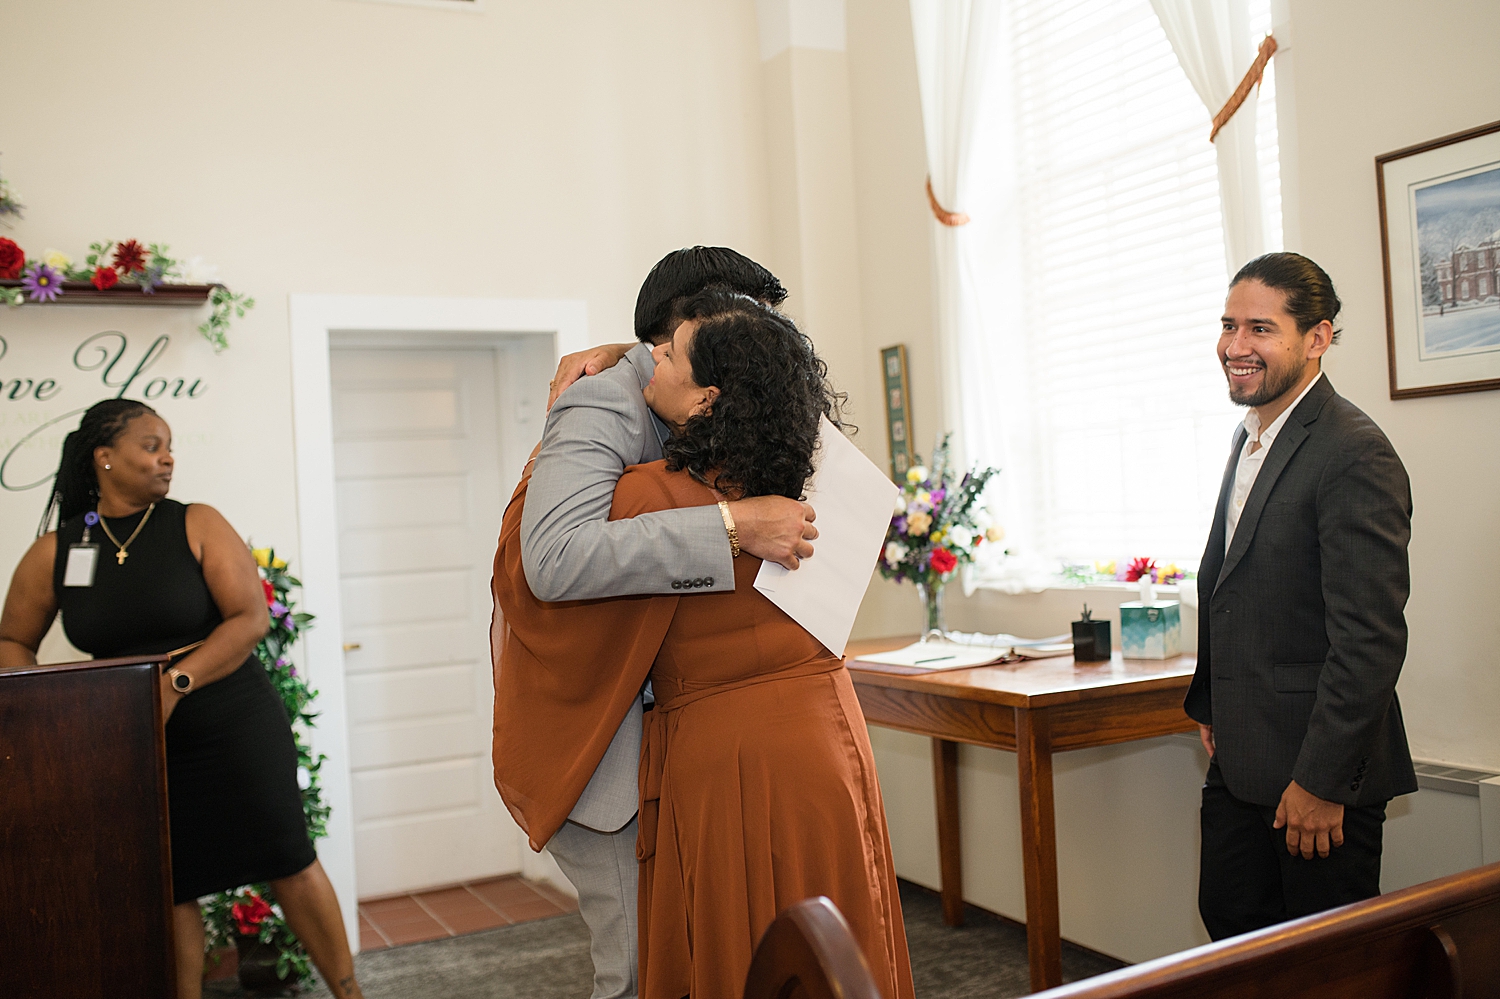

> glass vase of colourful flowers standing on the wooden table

[{"left": 881, "top": 435, "right": 1004, "bottom": 642}]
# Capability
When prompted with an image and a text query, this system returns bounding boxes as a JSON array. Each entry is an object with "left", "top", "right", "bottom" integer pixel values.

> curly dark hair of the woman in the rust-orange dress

[{"left": 663, "top": 288, "right": 852, "bottom": 500}]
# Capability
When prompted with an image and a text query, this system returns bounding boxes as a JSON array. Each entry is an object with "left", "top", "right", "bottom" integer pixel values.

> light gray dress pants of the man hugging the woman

[{"left": 548, "top": 819, "right": 641, "bottom": 999}]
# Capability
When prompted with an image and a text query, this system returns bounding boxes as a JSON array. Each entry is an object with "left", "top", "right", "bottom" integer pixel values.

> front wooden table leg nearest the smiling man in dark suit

[{"left": 1016, "top": 708, "right": 1062, "bottom": 992}]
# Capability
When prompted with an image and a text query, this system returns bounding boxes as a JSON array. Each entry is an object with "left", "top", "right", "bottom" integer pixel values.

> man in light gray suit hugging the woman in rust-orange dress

[{"left": 521, "top": 246, "right": 818, "bottom": 999}]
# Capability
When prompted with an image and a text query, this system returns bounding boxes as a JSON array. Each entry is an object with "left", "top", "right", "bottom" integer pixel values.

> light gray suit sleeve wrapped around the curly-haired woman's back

[{"left": 521, "top": 375, "right": 735, "bottom": 600}]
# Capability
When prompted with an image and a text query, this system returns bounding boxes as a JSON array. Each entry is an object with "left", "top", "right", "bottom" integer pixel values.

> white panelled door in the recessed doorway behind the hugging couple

[{"left": 330, "top": 348, "right": 519, "bottom": 897}]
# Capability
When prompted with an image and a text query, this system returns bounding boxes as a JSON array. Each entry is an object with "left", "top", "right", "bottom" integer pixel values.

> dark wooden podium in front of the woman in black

[{"left": 0, "top": 656, "right": 177, "bottom": 999}]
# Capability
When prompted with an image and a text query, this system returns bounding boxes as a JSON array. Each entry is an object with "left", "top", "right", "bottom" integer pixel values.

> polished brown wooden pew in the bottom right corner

[{"left": 1035, "top": 864, "right": 1500, "bottom": 999}]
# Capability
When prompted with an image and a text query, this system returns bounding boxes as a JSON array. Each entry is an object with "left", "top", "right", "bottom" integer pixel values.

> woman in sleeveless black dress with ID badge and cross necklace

[{"left": 0, "top": 399, "right": 362, "bottom": 999}]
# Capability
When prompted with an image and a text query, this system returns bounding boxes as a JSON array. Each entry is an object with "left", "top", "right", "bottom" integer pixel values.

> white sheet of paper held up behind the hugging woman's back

[{"left": 755, "top": 417, "right": 899, "bottom": 656}]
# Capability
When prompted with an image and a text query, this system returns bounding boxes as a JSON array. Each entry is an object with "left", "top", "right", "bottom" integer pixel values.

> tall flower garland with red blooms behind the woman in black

[{"left": 203, "top": 548, "right": 330, "bottom": 986}]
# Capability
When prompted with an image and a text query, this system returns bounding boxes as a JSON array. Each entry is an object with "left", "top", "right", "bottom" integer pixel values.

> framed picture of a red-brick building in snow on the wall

[{"left": 1376, "top": 122, "right": 1500, "bottom": 399}]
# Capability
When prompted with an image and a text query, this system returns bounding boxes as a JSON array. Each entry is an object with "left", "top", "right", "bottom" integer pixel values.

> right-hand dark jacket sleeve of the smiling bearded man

[{"left": 1292, "top": 435, "right": 1412, "bottom": 804}]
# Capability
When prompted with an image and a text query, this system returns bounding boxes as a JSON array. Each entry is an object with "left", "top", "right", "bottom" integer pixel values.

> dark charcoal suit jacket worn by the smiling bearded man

[{"left": 1184, "top": 375, "right": 1416, "bottom": 806}]
